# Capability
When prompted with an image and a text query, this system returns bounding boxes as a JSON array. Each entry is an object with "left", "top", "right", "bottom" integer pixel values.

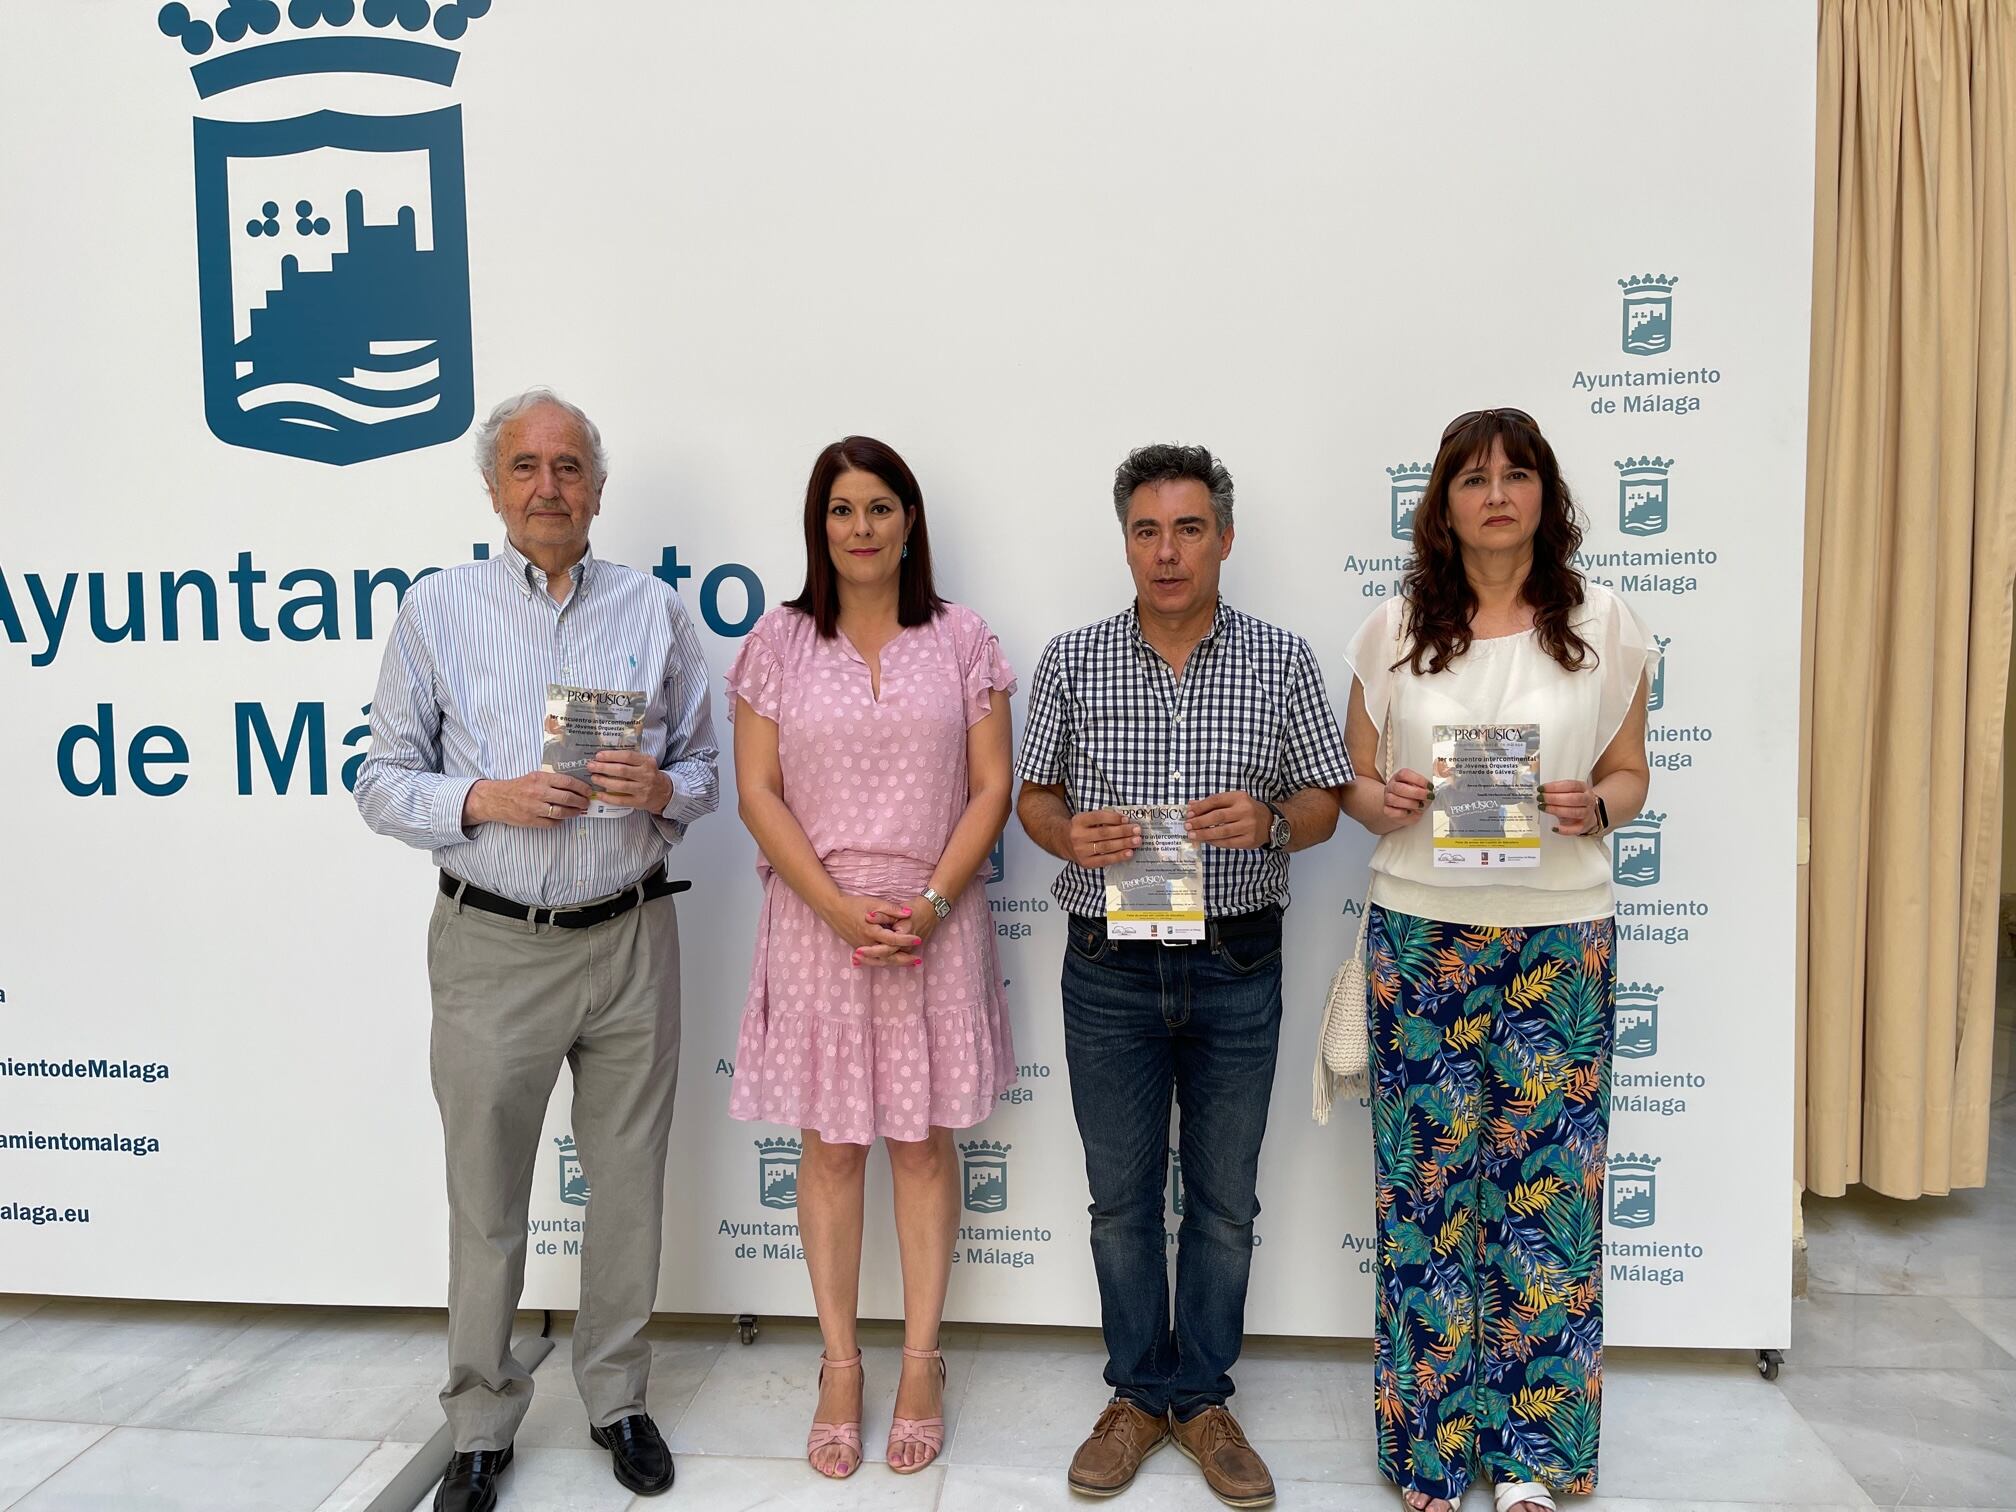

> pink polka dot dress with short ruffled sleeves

[{"left": 728, "top": 605, "right": 1014, "bottom": 1145}]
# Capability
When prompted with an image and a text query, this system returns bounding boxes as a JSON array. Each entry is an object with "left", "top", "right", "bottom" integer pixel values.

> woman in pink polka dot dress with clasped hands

[{"left": 728, "top": 435, "right": 1014, "bottom": 1480}]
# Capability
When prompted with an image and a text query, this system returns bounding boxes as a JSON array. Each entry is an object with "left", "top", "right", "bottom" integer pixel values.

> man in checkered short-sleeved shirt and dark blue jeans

[{"left": 1016, "top": 446, "right": 1351, "bottom": 1506}]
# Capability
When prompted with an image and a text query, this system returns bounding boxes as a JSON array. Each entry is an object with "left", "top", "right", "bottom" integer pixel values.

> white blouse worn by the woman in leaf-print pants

[{"left": 1345, "top": 583, "right": 1659, "bottom": 927}]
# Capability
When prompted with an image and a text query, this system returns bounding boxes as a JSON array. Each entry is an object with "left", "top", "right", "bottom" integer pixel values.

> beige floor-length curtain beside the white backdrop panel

[{"left": 1798, "top": 0, "right": 2016, "bottom": 1198}]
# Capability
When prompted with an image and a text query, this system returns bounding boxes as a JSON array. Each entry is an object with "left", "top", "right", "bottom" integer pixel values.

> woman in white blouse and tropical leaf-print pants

[{"left": 1345, "top": 409, "right": 1657, "bottom": 1512}]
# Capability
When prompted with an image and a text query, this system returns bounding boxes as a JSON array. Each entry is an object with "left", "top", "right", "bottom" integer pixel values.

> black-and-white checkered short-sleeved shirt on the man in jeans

[{"left": 1016, "top": 599, "right": 1351, "bottom": 919}]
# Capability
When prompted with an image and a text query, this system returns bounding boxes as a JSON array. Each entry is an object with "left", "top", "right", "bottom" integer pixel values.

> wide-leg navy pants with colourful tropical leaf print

[{"left": 1365, "top": 905, "right": 1617, "bottom": 1502}]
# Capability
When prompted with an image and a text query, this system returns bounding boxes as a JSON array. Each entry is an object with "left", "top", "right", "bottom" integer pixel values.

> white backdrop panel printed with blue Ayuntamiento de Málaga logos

[{"left": 0, "top": 0, "right": 1812, "bottom": 1345}]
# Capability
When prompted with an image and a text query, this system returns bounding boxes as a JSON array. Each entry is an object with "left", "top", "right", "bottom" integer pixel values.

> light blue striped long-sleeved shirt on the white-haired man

[{"left": 357, "top": 546, "right": 720, "bottom": 907}]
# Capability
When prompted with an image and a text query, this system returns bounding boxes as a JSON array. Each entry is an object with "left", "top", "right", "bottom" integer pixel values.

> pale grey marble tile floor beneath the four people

[{"left": 0, "top": 1008, "right": 2016, "bottom": 1512}]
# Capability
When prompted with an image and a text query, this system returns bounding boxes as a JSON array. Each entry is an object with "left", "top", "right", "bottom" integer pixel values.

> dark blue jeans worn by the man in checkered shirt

[{"left": 1064, "top": 909, "right": 1280, "bottom": 1419}]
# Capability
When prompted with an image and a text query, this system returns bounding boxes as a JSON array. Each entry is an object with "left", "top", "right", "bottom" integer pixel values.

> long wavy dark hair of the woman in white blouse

[{"left": 1393, "top": 409, "right": 1597, "bottom": 675}]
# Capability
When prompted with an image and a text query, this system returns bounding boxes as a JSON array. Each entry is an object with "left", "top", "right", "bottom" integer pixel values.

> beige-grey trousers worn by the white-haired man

[{"left": 427, "top": 895, "right": 679, "bottom": 1452}]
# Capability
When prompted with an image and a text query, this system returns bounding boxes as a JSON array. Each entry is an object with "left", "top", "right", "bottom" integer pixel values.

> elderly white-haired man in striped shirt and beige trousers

[{"left": 357, "top": 389, "right": 720, "bottom": 1512}]
